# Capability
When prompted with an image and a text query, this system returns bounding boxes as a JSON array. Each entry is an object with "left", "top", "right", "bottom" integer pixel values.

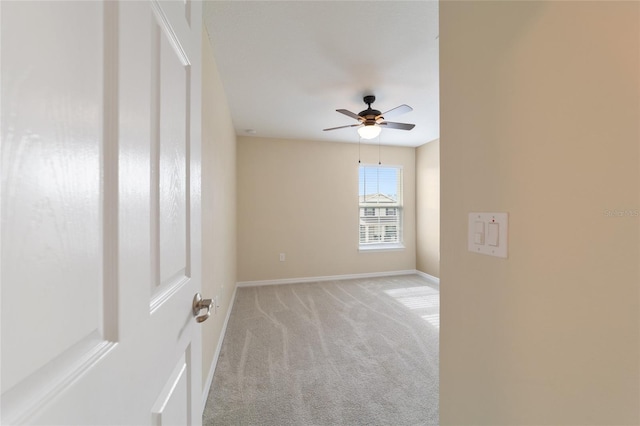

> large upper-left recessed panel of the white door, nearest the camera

[{"left": 1, "top": 2, "right": 111, "bottom": 404}]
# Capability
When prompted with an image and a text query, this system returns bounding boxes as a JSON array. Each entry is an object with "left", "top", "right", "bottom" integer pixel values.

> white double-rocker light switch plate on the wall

[{"left": 468, "top": 212, "right": 509, "bottom": 258}]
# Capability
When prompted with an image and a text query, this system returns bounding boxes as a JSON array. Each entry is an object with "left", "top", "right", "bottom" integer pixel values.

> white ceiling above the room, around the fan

[{"left": 204, "top": 0, "right": 440, "bottom": 147}]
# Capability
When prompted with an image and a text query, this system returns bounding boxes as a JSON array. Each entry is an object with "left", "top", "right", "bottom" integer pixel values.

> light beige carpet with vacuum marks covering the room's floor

[{"left": 203, "top": 275, "right": 439, "bottom": 426}]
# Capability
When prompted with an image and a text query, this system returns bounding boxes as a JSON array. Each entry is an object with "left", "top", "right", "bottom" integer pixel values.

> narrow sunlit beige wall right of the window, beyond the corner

[{"left": 416, "top": 140, "right": 440, "bottom": 277}]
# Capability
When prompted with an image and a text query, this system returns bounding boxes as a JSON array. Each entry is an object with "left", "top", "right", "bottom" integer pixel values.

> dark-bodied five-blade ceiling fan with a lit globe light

[{"left": 322, "top": 95, "right": 415, "bottom": 139}]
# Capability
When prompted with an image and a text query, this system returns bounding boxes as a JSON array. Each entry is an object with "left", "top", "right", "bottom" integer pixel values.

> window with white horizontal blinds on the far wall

[{"left": 358, "top": 166, "right": 403, "bottom": 250}]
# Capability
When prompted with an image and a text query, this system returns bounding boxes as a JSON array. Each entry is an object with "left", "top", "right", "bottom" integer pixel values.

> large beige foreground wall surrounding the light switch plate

[{"left": 440, "top": 1, "right": 640, "bottom": 425}]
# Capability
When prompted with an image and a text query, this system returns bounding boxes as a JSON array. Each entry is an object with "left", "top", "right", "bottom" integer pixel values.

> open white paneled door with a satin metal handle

[{"left": 0, "top": 0, "right": 206, "bottom": 425}]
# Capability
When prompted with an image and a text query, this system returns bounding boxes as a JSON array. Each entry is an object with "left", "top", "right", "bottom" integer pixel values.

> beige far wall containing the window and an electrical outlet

[{"left": 237, "top": 137, "right": 416, "bottom": 281}]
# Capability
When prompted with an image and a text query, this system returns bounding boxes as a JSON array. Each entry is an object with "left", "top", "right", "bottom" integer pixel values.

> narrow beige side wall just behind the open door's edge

[{"left": 201, "top": 31, "right": 236, "bottom": 388}]
